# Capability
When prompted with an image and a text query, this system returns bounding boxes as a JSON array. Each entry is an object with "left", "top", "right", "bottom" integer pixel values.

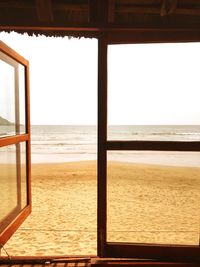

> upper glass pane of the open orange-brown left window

[{"left": 0, "top": 52, "right": 25, "bottom": 137}]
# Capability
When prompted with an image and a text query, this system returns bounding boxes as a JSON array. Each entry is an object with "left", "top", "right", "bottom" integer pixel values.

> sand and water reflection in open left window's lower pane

[{"left": 0, "top": 145, "right": 18, "bottom": 221}]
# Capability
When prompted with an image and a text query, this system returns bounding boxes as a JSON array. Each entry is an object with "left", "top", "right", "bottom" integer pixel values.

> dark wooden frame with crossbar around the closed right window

[{"left": 97, "top": 32, "right": 200, "bottom": 262}]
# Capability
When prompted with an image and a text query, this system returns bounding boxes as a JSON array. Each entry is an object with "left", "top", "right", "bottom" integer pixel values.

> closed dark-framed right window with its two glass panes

[{"left": 98, "top": 38, "right": 200, "bottom": 260}]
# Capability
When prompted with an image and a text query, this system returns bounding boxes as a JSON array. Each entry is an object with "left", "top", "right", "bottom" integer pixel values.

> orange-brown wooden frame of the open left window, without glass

[{"left": 0, "top": 41, "right": 31, "bottom": 245}]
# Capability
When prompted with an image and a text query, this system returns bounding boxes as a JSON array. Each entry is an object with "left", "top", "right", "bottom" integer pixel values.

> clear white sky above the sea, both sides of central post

[{"left": 0, "top": 33, "right": 200, "bottom": 125}]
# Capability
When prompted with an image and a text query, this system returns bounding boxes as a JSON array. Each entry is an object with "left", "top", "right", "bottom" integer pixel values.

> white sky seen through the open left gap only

[{"left": 0, "top": 33, "right": 97, "bottom": 125}]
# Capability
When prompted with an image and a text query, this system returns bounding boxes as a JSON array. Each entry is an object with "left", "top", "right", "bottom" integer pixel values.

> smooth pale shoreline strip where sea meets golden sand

[{"left": 31, "top": 151, "right": 200, "bottom": 167}]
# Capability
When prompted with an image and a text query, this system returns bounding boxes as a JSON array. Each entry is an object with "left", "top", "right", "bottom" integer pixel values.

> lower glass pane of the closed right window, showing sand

[{"left": 107, "top": 151, "right": 200, "bottom": 245}]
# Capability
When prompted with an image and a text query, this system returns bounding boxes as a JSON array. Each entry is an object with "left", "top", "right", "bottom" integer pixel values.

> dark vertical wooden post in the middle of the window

[{"left": 97, "top": 37, "right": 107, "bottom": 257}]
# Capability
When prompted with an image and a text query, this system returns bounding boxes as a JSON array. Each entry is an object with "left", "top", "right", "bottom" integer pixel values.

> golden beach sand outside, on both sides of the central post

[{"left": 2, "top": 161, "right": 200, "bottom": 256}]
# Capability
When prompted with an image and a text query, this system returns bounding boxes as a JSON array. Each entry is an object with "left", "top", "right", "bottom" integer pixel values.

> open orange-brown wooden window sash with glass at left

[{"left": 0, "top": 42, "right": 31, "bottom": 245}]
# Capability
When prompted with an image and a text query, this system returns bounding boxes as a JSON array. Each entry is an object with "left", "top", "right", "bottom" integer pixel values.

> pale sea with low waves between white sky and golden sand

[{"left": 31, "top": 125, "right": 200, "bottom": 167}]
